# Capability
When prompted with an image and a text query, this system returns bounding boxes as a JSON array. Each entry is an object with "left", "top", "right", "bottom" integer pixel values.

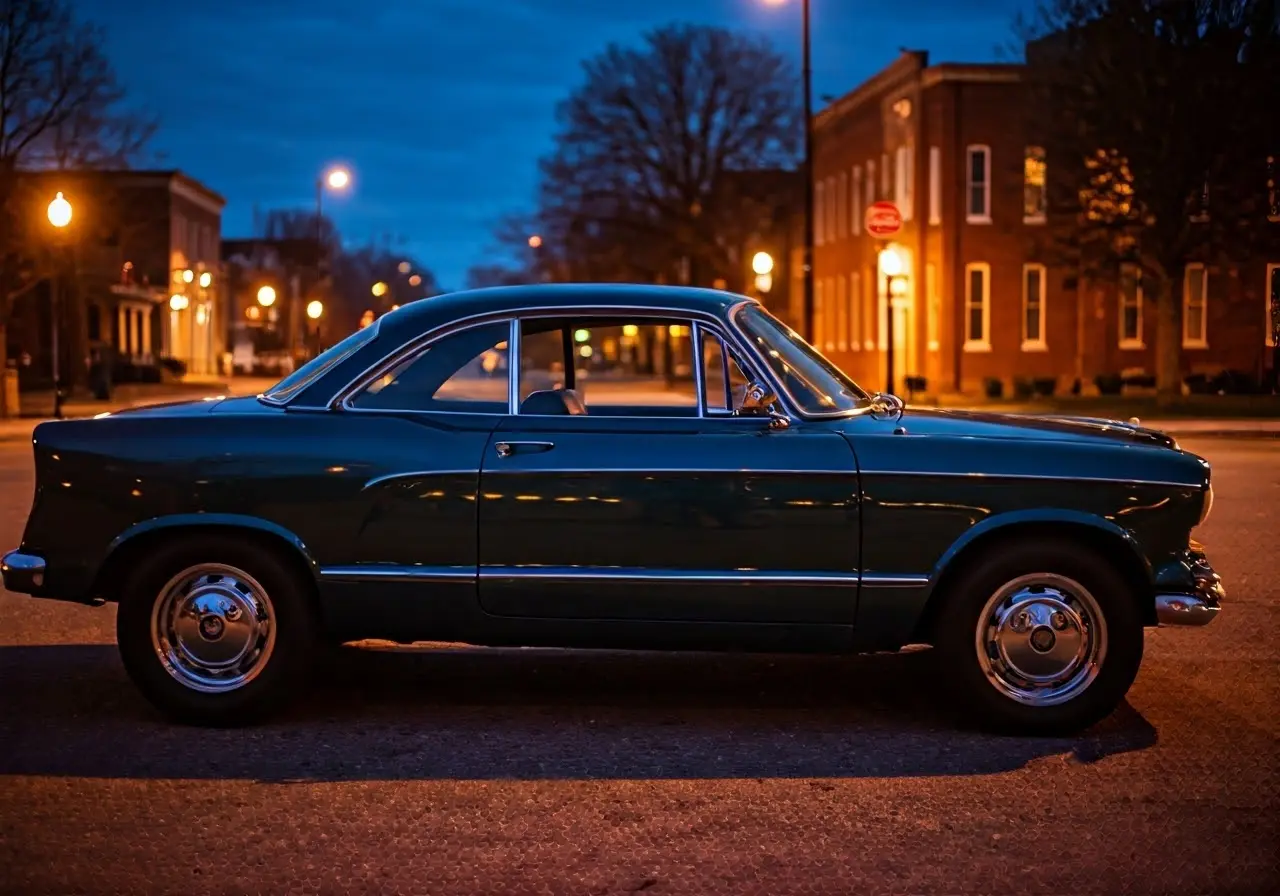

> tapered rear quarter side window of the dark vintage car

[{"left": 351, "top": 321, "right": 511, "bottom": 413}]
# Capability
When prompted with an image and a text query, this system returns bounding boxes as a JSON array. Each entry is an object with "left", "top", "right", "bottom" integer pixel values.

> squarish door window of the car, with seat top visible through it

[{"left": 520, "top": 316, "right": 698, "bottom": 417}]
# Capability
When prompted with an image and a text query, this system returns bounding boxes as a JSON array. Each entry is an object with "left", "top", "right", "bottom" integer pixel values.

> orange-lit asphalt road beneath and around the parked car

[{"left": 0, "top": 440, "right": 1280, "bottom": 896}]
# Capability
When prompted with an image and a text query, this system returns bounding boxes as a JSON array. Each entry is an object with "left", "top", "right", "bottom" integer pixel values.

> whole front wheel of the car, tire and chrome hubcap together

[{"left": 934, "top": 543, "right": 1143, "bottom": 735}]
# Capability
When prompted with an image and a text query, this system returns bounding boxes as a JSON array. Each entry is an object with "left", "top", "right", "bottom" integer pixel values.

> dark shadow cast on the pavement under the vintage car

[{"left": 0, "top": 645, "right": 1156, "bottom": 783}]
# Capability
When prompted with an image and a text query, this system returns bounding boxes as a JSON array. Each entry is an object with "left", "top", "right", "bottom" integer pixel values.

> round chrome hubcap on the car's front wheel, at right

[{"left": 974, "top": 572, "right": 1107, "bottom": 707}]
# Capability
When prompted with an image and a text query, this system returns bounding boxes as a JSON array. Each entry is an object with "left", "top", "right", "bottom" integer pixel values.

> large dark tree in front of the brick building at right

[{"left": 1020, "top": 0, "right": 1280, "bottom": 396}]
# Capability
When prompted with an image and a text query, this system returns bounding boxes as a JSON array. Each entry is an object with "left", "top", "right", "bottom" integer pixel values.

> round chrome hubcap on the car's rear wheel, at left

[{"left": 151, "top": 563, "right": 275, "bottom": 694}]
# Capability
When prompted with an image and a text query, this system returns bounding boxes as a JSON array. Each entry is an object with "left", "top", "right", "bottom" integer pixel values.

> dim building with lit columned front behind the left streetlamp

[{"left": 8, "top": 170, "right": 225, "bottom": 381}]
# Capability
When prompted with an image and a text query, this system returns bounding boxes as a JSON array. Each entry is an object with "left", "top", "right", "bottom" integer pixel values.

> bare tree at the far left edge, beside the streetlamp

[{"left": 0, "top": 0, "right": 154, "bottom": 407}]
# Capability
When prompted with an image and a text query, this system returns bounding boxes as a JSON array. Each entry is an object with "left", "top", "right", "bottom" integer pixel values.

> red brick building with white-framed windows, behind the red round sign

[{"left": 791, "top": 51, "right": 1280, "bottom": 394}]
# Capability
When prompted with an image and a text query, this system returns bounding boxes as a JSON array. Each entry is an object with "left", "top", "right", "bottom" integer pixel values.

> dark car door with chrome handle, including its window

[{"left": 479, "top": 316, "right": 859, "bottom": 625}]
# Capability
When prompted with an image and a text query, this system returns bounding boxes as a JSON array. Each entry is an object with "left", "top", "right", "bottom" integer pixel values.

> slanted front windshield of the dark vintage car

[{"left": 735, "top": 305, "right": 870, "bottom": 415}]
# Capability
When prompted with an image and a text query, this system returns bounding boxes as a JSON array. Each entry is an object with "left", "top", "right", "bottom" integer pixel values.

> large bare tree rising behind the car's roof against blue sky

[{"left": 524, "top": 24, "right": 801, "bottom": 284}]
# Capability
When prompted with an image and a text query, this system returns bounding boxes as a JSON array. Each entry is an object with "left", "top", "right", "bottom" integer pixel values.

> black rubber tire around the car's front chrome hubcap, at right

[{"left": 933, "top": 540, "right": 1143, "bottom": 736}]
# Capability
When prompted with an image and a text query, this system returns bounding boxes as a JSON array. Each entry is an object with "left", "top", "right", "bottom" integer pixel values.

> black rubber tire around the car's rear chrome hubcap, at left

[{"left": 115, "top": 534, "right": 320, "bottom": 727}]
